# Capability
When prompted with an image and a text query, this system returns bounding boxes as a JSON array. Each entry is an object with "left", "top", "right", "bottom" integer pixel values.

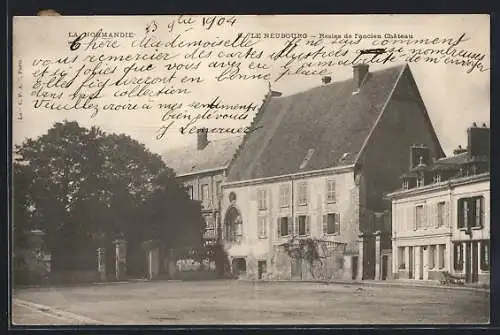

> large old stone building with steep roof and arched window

[{"left": 222, "top": 65, "right": 444, "bottom": 280}]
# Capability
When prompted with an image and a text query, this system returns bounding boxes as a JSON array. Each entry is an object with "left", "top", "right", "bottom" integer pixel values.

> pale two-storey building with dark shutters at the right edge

[{"left": 387, "top": 124, "right": 490, "bottom": 283}]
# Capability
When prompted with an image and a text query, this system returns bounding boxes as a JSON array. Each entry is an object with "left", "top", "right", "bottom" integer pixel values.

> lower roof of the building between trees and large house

[{"left": 162, "top": 136, "right": 242, "bottom": 176}]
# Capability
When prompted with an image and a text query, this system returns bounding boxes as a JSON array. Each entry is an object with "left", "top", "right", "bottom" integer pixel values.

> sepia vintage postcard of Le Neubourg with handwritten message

[{"left": 11, "top": 12, "right": 491, "bottom": 325}]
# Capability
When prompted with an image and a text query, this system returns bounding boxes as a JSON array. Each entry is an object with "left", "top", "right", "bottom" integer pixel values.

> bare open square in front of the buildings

[{"left": 13, "top": 280, "right": 490, "bottom": 325}]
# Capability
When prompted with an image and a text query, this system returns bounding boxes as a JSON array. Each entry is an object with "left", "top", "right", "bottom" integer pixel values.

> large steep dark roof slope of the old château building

[{"left": 227, "top": 65, "right": 409, "bottom": 181}]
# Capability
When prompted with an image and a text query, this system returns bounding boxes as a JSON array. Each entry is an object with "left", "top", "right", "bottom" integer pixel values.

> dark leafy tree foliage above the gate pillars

[{"left": 13, "top": 121, "right": 203, "bottom": 268}]
